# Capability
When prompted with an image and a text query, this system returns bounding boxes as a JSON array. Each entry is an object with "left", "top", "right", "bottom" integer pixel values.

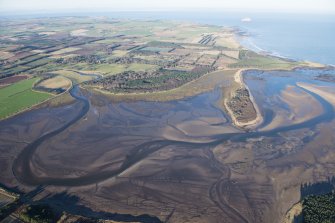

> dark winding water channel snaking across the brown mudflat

[{"left": 13, "top": 67, "right": 334, "bottom": 186}]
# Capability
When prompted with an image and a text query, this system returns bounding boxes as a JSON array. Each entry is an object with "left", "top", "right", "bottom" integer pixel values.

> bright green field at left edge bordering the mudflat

[{"left": 0, "top": 78, "right": 52, "bottom": 119}]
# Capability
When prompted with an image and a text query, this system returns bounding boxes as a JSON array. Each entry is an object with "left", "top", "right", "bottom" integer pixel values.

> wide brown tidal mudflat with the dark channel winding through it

[{"left": 0, "top": 69, "right": 335, "bottom": 223}]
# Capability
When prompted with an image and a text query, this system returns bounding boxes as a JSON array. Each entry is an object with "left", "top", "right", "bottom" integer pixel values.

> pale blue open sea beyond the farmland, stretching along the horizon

[{"left": 1, "top": 10, "right": 335, "bottom": 66}]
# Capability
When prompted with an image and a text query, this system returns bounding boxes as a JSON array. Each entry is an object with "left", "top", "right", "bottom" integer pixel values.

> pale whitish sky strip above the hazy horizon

[{"left": 0, "top": 0, "right": 335, "bottom": 14}]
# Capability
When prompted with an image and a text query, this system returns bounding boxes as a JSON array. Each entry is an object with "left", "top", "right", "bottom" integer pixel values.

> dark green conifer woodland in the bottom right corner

[{"left": 302, "top": 193, "right": 335, "bottom": 223}]
